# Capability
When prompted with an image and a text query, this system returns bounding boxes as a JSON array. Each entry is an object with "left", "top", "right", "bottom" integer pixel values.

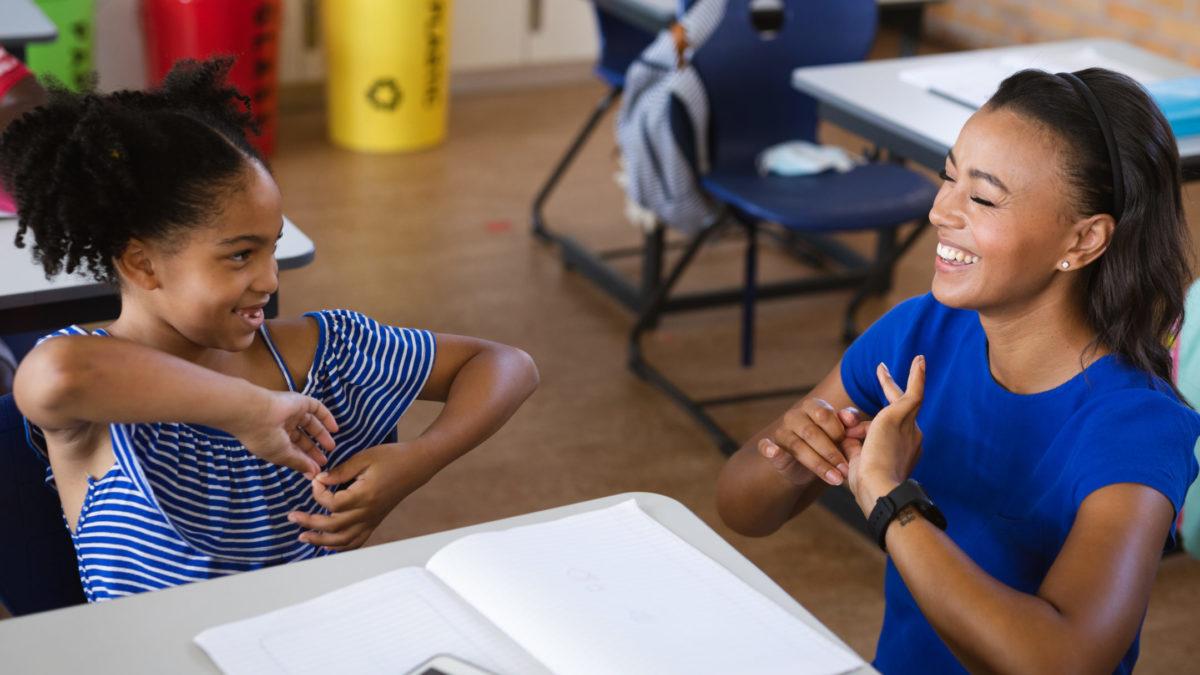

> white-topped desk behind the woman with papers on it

[{"left": 792, "top": 40, "right": 1200, "bottom": 179}]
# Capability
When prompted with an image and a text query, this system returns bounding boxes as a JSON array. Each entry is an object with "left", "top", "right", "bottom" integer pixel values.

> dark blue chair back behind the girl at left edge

[{"left": 0, "top": 394, "right": 85, "bottom": 616}]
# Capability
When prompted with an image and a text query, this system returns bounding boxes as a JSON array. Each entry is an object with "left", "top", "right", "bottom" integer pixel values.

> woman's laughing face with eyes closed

[{"left": 929, "top": 108, "right": 1075, "bottom": 312}]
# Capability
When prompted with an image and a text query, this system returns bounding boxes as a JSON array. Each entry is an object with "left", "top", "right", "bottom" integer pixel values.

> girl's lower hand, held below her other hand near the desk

[{"left": 288, "top": 443, "right": 434, "bottom": 551}]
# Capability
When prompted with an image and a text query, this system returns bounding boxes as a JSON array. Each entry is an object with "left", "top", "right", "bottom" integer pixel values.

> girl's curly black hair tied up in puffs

[{"left": 0, "top": 58, "right": 259, "bottom": 282}]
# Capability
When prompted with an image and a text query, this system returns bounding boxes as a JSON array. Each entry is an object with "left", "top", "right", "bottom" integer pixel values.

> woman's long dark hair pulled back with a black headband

[{"left": 986, "top": 68, "right": 1192, "bottom": 394}]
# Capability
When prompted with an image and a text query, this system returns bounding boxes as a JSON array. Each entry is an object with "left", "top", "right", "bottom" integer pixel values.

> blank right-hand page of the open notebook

[{"left": 426, "top": 500, "right": 863, "bottom": 675}]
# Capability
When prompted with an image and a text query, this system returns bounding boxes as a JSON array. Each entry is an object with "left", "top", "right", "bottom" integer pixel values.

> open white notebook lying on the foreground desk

[{"left": 196, "top": 500, "right": 863, "bottom": 675}]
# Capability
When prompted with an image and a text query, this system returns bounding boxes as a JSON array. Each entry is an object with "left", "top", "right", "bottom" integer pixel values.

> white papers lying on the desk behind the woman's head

[{"left": 899, "top": 47, "right": 1162, "bottom": 108}]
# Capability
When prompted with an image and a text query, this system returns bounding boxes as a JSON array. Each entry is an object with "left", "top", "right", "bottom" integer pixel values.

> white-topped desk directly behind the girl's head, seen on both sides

[{"left": 0, "top": 213, "right": 316, "bottom": 334}]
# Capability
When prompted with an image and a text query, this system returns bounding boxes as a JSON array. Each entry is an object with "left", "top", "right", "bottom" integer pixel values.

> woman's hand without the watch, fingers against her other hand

[{"left": 758, "top": 396, "right": 871, "bottom": 485}]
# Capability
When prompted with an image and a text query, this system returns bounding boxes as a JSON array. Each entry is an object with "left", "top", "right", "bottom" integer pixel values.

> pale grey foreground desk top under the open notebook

[{"left": 0, "top": 492, "right": 876, "bottom": 675}]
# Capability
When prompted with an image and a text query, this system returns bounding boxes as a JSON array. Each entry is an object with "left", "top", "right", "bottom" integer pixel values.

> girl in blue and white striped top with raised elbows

[{"left": 0, "top": 60, "right": 538, "bottom": 601}]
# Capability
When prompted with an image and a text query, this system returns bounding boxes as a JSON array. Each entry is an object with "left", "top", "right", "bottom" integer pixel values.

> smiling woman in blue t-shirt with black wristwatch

[{"left": 718, "top": 68, "right": 1200, "bottom": 675}]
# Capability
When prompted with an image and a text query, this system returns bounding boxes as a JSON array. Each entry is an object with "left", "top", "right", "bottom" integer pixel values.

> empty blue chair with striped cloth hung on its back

[{"left": 629, "top": 0, "right": 937, "bottom": 453}]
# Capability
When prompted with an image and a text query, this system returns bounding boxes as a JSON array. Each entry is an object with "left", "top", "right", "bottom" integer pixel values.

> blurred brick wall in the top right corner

[{"left": 925, "top": 0, "right": 1200, "bottom": 67}]
